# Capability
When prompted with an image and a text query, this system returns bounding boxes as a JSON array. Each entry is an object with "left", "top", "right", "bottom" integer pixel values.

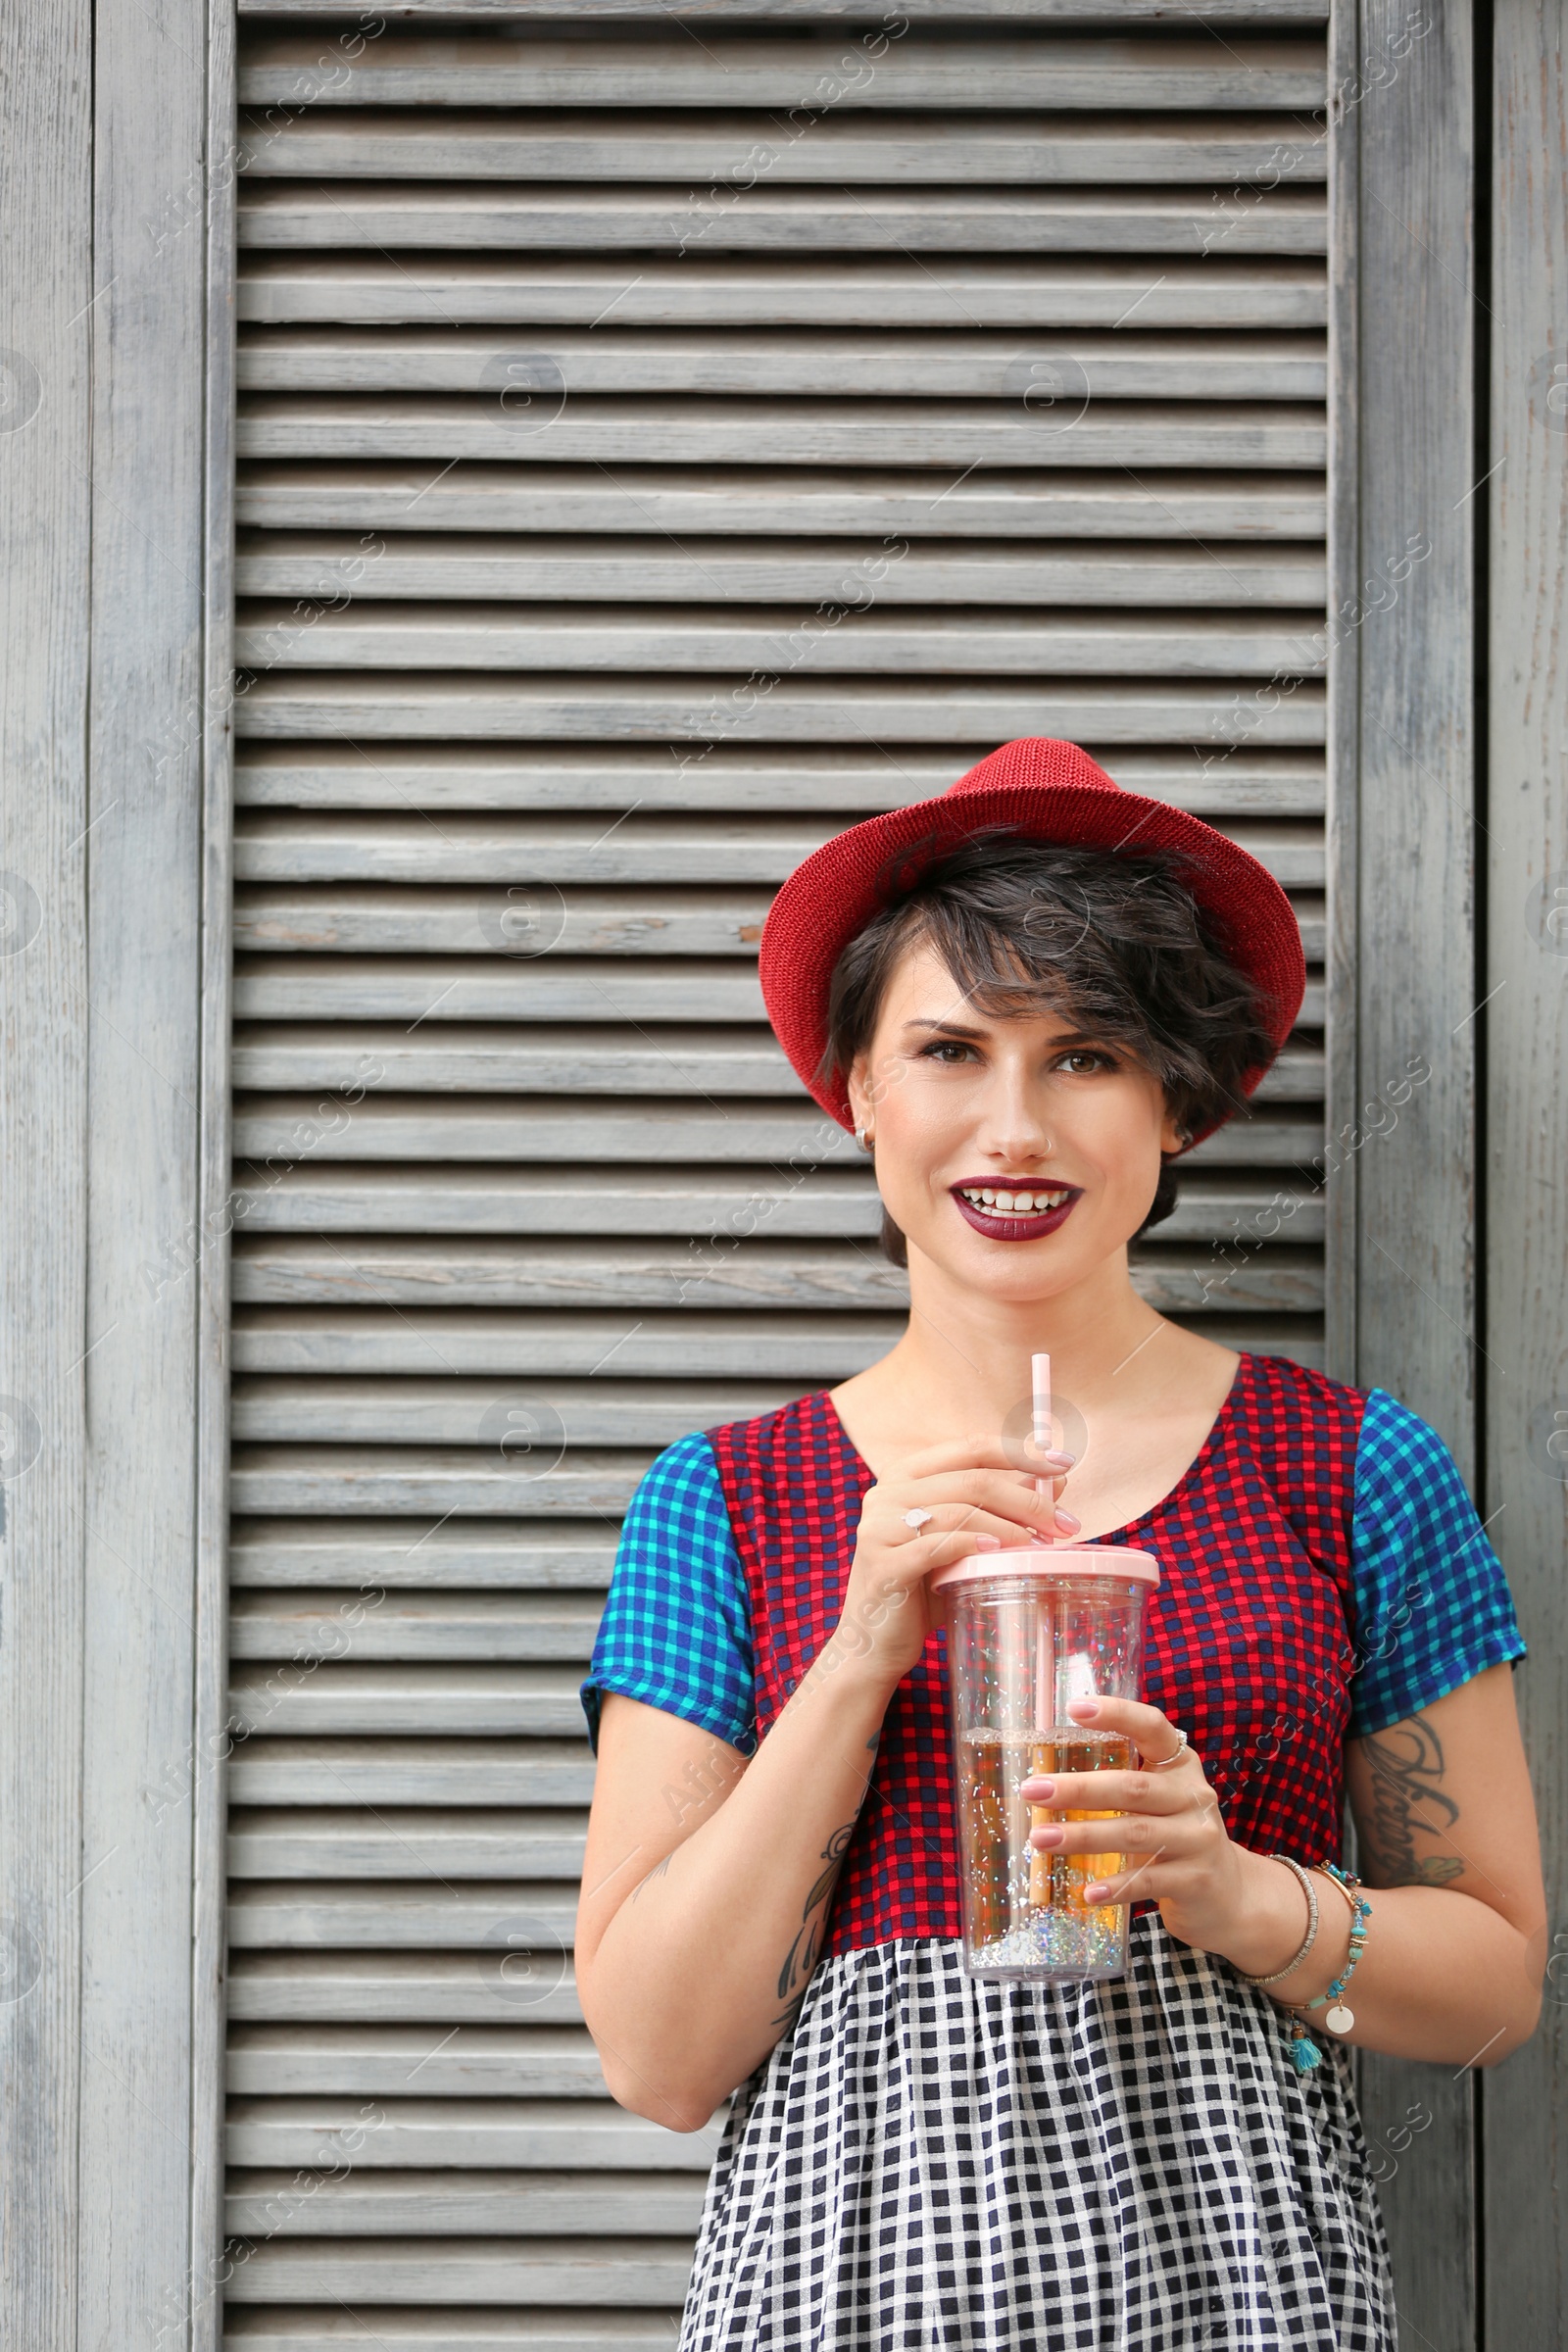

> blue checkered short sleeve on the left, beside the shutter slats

[{"left": 583, "top": 1437, "right": 757, "bottom": 1754}]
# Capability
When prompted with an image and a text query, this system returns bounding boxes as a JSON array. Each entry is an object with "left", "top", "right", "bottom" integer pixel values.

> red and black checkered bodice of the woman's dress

[{"left": 708, "top": 1354, "right": 1366, "bottom": 1952}]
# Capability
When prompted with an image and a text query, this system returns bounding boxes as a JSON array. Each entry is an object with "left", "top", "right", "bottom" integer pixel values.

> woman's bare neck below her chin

[{"left": 884, "top": 1249, "right": 1171, "bottom": 1430}]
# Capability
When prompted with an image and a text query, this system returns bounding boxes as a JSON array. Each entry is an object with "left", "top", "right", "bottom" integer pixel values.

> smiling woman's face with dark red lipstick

[{"left": 849, "top": 946, "right": 1180, "bottom": 1298}]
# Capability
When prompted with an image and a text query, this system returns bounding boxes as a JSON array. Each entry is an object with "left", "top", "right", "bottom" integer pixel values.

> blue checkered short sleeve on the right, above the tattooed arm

[{"left": 1349, "top": 1388, "right": 1523, "bottom": 1739}]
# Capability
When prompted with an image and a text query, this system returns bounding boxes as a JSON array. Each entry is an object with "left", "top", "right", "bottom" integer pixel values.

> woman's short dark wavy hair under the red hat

[{"left": 823, "top": 828, "right": 1274, "bottom": 1265}]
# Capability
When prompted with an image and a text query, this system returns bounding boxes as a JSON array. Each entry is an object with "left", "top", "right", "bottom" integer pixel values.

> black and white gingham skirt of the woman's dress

[{"left": 682, "top": 1912, "right": 1394, "bottom": 2352}]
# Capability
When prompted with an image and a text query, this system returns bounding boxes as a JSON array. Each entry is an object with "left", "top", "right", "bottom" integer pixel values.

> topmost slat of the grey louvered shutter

[{"left": 240, "top": 30, "right": 1324, "bottom": 113}]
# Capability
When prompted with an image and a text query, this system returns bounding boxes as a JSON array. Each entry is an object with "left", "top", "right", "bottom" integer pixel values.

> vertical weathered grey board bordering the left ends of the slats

[{"left": 82, "top": 0, "right": 225, "bottom": 2347}]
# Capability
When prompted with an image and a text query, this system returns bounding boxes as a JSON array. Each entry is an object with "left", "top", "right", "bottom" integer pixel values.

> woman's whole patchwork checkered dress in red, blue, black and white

[{"left": 583, "top": 1357, "right": 1523, "bottom": 2352}]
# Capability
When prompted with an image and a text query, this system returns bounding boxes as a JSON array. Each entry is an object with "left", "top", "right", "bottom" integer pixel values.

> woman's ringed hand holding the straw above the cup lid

[{"left": 823, "top": 1437, "right": 1079, "bottom": 1682}]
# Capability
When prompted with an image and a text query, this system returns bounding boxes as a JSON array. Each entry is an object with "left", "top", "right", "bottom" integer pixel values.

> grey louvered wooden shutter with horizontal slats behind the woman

[{"left": 228, "top": 0, "right": 1326, "bottom": 2352}]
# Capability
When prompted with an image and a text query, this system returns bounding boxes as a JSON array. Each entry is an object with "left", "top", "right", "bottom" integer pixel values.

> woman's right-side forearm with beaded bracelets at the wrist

[{"left": 1222, "top": 1853, "right": 1540, "bottom": 2068}]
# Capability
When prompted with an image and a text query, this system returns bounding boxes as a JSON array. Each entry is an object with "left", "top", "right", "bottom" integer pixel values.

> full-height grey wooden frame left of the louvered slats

[{"left": 0, "top": 0, "right": 232, "bottom": 2352}]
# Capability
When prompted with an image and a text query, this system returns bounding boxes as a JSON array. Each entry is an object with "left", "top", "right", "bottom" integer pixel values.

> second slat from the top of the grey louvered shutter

[{"left": 240, "top": 108, "right": 1326, "bottom": 188}]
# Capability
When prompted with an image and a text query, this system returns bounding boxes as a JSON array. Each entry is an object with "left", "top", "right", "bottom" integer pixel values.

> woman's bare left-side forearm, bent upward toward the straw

[{"left": 581, "top": 1637, "right": 894, "bottom": 2131}]
